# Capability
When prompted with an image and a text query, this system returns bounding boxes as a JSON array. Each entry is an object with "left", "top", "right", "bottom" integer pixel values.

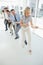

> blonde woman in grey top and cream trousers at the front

[{"left": 20, "top": 7, "right": 38, "bottom": 53}]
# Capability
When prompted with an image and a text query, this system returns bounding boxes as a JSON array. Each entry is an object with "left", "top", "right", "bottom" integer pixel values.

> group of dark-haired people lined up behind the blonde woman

[{"left": 3, "top": 7, "right": 20, "bottom": 39}]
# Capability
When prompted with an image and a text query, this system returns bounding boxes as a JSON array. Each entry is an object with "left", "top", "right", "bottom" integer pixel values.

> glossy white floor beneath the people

[{"left": 0, "top": 17, "right": 43, "bottom": 65}]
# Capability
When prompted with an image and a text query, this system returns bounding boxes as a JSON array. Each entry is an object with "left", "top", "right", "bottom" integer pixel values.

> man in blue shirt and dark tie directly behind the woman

[{"left": 11, "top": 9, "right": 20, "bottom": 39}]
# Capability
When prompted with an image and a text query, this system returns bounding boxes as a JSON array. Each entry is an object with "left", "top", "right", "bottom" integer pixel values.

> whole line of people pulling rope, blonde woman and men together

[{"left": 2, "top": 7, "right": 38, "bottom": 53}]
